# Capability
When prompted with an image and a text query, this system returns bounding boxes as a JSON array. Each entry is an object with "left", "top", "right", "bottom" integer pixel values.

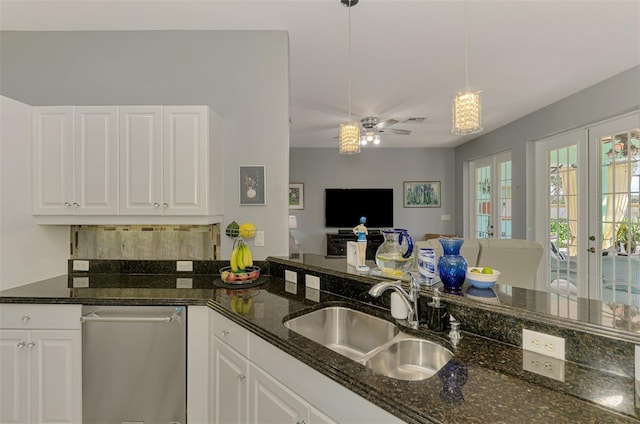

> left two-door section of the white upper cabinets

[{"left": 32, "top": 106, "right": 118, "bottom": 215}]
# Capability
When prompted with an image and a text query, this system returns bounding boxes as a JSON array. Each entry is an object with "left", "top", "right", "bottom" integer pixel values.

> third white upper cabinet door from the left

[{"left": 119, "top": 106, "right": 164, "bottom": 215}]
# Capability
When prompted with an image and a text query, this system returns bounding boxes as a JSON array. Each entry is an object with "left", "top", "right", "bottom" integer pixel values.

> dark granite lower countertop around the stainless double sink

[{"left": 0, "top": 264, "right": 639, "bottom": 423}]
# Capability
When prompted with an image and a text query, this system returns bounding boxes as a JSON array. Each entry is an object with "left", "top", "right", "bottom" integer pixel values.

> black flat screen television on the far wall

[{"left": 324, "top": 188, "right": 393, "bottom": 228}]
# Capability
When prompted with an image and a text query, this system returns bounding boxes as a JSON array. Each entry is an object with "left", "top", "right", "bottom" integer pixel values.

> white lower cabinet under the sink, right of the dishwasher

[{"left": 202, "top": 310, "right": 402, "bottom": 424}]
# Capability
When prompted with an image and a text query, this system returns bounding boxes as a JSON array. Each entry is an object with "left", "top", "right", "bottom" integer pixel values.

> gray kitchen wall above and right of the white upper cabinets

[{"left": 0, "top": 31, "right": 289, "bottom": 259}]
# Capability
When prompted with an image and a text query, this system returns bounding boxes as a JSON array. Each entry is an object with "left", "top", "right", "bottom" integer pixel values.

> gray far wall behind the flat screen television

[{"left": 289, "top": 146, "right": 456, "bottom": 254}]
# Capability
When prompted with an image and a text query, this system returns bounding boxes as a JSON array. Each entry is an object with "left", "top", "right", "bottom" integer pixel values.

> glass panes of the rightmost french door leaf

[{"left": 599, "top": 128, "right": 640, "bottom": 305}]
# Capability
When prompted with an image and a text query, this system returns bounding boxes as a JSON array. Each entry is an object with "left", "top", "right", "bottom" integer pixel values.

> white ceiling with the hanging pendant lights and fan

[{"left": 0, "top": 0, "right": 640, "bottom": 147}]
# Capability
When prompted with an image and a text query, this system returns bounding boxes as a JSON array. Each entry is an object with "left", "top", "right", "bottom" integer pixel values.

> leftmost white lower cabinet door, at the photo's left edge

[{"left": 0, "top": 330, "right": 29, "bottom": 423}]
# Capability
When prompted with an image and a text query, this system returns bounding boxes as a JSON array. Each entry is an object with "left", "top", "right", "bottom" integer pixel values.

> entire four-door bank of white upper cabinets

[{"left": 33, "top": 106, "right": 224, "bottom": 224}]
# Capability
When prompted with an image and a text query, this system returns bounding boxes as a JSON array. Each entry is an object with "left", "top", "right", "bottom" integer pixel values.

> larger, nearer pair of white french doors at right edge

[{"left": 535, "top": 113, "right": 640, "bottom": 303}]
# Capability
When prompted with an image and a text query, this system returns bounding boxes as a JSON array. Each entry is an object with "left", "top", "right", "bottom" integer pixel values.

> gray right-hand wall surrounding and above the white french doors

[{"left": 455, "top": 66, "right": 640, "bottom": 238}]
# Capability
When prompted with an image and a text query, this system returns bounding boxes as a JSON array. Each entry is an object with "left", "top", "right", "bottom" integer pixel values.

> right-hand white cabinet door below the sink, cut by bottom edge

[{"left": 249, "top": 365, "right": 309, "bottom": 424}]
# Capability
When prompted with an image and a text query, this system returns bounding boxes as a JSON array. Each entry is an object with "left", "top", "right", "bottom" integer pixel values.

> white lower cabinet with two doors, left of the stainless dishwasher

[{"left": 0, "top": 304, "right": 82, "bottom": 423}]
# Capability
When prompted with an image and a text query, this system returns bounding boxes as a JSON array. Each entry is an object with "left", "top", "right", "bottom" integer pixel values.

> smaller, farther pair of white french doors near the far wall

[{"left": 469, "top": 151, "right": 512, "bottom": 238}]
